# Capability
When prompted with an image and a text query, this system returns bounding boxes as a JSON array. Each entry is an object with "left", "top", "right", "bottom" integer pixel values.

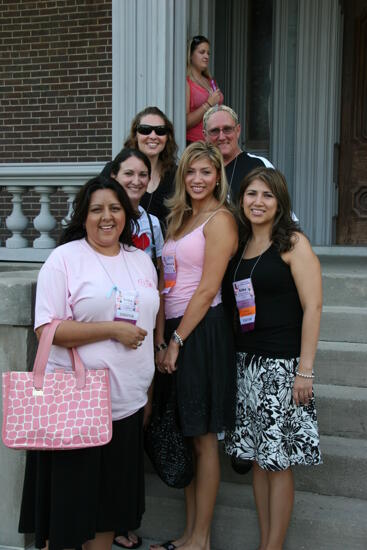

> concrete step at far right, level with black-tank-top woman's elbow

[{"left": 322, "top": 269, "right": 367, "bottom": 307}]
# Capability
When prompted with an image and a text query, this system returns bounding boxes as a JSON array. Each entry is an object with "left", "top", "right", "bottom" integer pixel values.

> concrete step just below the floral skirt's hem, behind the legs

[{"left": 220, "top": 435, "right": 367, "bottom": 500}]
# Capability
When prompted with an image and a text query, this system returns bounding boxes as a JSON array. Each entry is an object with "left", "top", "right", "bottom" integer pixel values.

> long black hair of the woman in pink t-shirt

[{"left": 58, "top": 175, "right": 138, "bottom": 246}]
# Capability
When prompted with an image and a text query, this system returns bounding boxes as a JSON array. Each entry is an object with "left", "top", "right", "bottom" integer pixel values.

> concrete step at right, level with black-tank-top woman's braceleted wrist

[{"left": 315, "top": 341, "right": 367, "bottom": 388}]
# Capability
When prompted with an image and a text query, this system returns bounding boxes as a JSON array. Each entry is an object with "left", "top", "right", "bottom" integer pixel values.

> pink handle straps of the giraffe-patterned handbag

[{"left": 33, "top": 319, "right": 85, "bottom": 390}]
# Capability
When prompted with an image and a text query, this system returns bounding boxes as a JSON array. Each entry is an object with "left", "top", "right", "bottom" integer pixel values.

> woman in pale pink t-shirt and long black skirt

[{"left": 19, "top": 176, "right": 159, "bottom": 550}]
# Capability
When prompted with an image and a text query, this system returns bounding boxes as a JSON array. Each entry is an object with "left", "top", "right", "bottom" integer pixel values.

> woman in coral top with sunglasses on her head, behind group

[{"left": 186, "top": 35, "right": 223, "bottom": 145}]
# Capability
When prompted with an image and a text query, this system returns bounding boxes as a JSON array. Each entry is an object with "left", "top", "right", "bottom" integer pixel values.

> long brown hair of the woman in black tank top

[{"left": 237, "top": 167, "right": 302, "bottom": 253}]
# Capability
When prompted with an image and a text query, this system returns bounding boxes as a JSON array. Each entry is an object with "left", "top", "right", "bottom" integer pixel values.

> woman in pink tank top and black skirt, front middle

[{"left": 154, "top": 141, "right": 237, "bottom": 550}]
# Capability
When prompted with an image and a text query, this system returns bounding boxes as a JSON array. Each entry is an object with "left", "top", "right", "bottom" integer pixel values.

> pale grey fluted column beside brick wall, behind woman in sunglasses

[{"left": 112, "top": 0, "right": 187, "bottom": 155}]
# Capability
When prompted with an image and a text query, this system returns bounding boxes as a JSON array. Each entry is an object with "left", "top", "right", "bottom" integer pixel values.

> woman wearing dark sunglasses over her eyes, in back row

[{"left": 125, "top": 107, "right": 178, "bottom": 230}]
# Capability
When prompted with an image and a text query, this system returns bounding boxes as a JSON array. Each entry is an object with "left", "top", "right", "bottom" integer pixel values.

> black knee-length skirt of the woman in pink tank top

[{"left": 165, "top": 304, "right": 236, "bottom": 437}]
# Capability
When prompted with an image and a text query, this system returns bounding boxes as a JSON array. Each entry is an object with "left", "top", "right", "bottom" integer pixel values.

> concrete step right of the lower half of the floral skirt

[{"left": 315, "top": 384, "right": 367, "bottom": 439}]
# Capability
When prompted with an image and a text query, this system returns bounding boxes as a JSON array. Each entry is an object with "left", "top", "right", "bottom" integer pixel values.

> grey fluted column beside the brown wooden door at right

[{"left": 290, "top": 0, "right": 342, "bottom": 245}]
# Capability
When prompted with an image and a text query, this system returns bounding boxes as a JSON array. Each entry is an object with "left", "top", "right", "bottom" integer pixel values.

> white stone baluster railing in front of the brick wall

[{"left": 0, "top": 163, "right": 103, "bottom": 262}]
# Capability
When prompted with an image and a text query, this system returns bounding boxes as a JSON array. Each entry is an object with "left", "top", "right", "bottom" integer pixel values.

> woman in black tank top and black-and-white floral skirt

[{"left": 223, "top": 167, "right": 322, "bottom": 550}]
